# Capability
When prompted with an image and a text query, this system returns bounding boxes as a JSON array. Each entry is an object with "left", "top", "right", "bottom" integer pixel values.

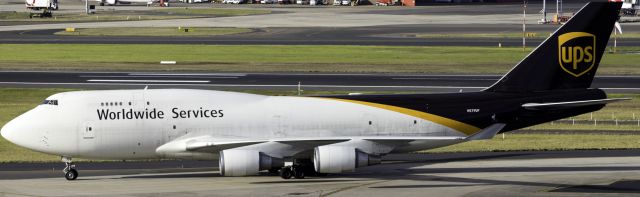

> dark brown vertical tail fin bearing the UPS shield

[{"left": 485, "top": 2, "right": 622, "bottom": 92}]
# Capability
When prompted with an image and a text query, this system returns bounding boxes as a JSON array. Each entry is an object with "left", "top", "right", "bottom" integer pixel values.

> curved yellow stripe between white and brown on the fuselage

[{"left": 324, "top": 98, "right": 481, "bottom": 135}]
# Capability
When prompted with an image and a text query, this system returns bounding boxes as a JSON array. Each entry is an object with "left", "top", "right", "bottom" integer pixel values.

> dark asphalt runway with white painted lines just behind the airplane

[{"left": 0, "top": 71, "right": 640, "bottom": 92}]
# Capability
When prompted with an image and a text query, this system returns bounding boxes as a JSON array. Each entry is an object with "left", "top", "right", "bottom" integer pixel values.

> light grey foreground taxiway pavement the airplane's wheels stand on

[{"left": 0, "top": 150, "right": 640, "bottom": 196}]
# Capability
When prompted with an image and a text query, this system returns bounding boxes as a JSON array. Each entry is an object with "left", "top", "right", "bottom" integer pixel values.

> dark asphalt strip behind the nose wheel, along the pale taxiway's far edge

[{"left": 0, "top": 149, "right": 640, "bottom": 180}]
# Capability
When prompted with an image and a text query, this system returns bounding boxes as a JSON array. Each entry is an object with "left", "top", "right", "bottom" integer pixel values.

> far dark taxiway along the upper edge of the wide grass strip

[{"left": 0, "top": 24, "right": 640, "bottom": 47}]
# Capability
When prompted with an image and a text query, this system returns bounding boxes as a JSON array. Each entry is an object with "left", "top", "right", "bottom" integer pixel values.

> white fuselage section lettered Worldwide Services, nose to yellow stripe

[{"left": 2, "top": 89, "right": 466, "bottom": 159}]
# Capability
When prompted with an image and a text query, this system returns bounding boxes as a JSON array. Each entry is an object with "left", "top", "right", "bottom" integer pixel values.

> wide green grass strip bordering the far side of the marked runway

[{"left": 0, "top": 44, "right": 640, "bottom": 75}]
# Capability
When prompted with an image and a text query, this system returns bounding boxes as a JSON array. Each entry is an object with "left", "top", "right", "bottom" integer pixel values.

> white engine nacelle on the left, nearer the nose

[{"left": 219, "top": 149, "right": 284, "bottom": 176}]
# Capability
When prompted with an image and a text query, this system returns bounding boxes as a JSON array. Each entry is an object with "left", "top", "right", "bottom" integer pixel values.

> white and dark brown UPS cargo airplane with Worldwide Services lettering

[{"left": 1, "top": 2, "right": 623, "bottom": 180}]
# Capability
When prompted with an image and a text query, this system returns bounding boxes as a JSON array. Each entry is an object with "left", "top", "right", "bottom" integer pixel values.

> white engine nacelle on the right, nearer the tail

[{"left": 313, "top": 146, "right": 381, "bottom": 173}]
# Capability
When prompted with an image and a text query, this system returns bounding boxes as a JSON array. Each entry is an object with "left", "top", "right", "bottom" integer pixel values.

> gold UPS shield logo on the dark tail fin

[{"left": 558, "top": 32, "right": 596, "bottom": 77}]
